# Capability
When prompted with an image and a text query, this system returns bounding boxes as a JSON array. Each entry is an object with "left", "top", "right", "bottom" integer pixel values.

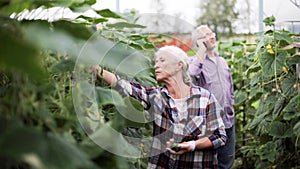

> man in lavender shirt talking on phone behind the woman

[{"left": 189, "top": 25, "right": 235, "bottom": 169}]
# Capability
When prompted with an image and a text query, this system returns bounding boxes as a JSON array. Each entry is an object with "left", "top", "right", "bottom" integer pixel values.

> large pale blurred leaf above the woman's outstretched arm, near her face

[{"left": 70, "top": 35, "right": 153, "bottom": 78}]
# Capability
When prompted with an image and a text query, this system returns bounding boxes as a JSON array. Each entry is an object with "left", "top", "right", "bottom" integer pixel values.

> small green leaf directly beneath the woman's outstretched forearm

[{"left": 95, "top": 87, "right": 125, "bottom": 106}]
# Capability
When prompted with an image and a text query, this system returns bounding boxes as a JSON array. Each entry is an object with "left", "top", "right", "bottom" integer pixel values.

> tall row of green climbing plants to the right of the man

[{"left": 219, "top": 16, "right": 300, "bottom": 168}]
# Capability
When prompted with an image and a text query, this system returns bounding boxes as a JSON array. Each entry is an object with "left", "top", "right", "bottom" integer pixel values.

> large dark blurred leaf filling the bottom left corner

[{"left": 0, "top": 120, "right": 95, "bottom": 169}]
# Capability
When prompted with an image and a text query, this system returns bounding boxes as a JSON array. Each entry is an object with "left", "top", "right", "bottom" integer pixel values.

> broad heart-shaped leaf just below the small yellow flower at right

[{"left": 260, "top": 50, "right": 287, "bottom": 77}]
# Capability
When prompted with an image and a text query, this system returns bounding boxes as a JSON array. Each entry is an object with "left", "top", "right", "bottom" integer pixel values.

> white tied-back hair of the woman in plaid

[{"left": 155, "top": 46, "right": 191, "bottom": 84}]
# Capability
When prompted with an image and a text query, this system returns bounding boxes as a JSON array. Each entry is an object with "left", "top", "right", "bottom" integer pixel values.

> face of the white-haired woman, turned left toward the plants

[{"left": 154, "top": 53, "right": 178, "bottom": 82}]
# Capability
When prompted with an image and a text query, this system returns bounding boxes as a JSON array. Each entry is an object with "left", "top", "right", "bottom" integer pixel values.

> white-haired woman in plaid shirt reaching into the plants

[{"left": 93, "top": 46, "right": 226, "bottom": 169}]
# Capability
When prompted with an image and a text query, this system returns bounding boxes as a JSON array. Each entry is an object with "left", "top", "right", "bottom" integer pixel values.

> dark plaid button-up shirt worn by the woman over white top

[{"left": 116, "top": 79, "right": 226, "bottom": 169}]
